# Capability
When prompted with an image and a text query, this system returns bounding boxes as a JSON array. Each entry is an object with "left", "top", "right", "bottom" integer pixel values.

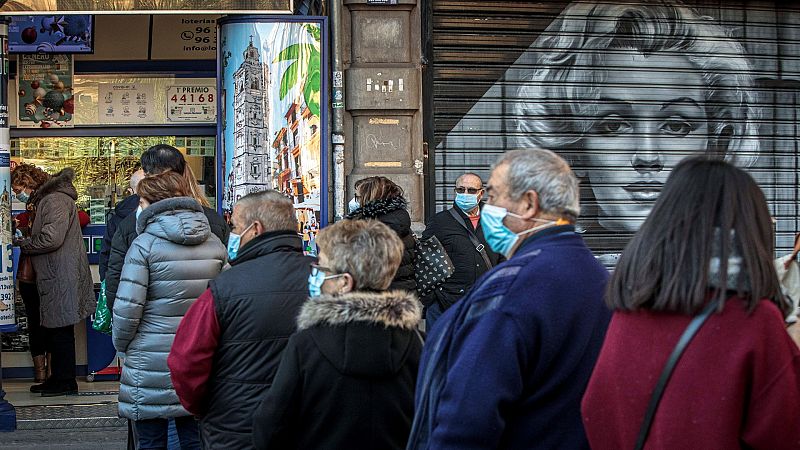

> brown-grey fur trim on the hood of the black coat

[{"left": 297, "top": 290, "right": 422, "bottom": 330}]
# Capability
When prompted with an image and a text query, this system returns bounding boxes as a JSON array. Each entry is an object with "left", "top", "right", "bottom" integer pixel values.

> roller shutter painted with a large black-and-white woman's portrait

[{"left": 432, "top": 0, "right": 800, "bottom": 254}]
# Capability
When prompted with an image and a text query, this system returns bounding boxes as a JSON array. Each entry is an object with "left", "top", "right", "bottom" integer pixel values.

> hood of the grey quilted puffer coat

[{"left": 136, "top": 197, "right": 211, "bottom": 245}]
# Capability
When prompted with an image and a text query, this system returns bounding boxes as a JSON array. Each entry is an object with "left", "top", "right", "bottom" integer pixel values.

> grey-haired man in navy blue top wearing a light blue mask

[{"left": 408, "top": 149, "right": 611, "bottom": 450}]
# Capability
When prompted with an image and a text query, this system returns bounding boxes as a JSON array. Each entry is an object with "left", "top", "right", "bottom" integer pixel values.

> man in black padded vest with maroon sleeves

[{"left": 167, "top": 190, "right": 316, "bottom": 449}]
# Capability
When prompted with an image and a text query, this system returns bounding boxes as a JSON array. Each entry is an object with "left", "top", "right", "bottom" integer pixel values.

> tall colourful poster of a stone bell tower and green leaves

[{"left": 218, "top": 18, "right": 327, "bottom": 249}]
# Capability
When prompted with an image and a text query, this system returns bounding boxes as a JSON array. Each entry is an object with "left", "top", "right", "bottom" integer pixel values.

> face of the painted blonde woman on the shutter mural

[{"left": 580, "top": 50, "right": 709, "bottom": 232}]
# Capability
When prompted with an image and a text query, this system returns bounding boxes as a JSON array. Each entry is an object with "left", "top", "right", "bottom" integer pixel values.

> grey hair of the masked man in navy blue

[{"left": 492, "top": 147, "right": 581, "bottom": 221}]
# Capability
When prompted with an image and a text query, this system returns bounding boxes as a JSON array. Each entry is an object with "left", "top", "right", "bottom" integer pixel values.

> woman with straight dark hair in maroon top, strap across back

[{"left": 582, "top": 157, "right": 800, "bottom": 449}]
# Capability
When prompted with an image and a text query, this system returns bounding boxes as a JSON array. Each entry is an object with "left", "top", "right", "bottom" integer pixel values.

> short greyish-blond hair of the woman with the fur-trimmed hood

[{"left": 317, "top": 220, "right": 403, "bottom": 291}]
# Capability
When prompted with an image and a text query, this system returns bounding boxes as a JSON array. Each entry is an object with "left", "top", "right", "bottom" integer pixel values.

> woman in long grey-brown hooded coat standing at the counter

[{"left": 11, "top": 164, "right": 95, "bottom": 397}]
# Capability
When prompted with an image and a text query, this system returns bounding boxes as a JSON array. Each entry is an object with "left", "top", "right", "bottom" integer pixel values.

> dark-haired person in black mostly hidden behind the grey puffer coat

[{"left": 105, "top": 144, "right": 230, "bottom": 309}]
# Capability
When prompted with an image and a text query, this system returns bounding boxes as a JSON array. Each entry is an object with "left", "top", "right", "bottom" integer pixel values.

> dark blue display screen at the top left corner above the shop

[{"left": 8, "top": 14, "right": 94, "bottom": 53}]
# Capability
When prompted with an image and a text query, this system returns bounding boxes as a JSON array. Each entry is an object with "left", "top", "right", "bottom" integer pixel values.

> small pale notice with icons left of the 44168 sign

[{"left": 97, "top": 83, "right": 155, "bottom": 125}]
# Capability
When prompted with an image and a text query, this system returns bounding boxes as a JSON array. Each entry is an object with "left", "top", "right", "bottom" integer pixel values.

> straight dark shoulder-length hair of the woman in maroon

[{"left": 606, "top": 157, "right": 790, "bottom": 314}]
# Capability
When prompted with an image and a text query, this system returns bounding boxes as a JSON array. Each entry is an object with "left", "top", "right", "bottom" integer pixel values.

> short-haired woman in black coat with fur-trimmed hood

[{"left": 253, "top": 220, "right": 422, "bottom": 450}]
